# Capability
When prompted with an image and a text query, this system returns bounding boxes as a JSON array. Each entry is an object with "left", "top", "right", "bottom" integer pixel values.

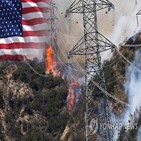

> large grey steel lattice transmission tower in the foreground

[{"left": 66, "top": 0, "right": 115, "bottom": 141}]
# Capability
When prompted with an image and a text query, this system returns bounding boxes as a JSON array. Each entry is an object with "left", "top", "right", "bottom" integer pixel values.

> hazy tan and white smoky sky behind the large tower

[{"left": 55, "top": 0, "right": 141, "bottom": 63}]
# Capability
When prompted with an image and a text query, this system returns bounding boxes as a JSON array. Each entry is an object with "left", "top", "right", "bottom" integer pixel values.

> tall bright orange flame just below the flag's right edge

[{"left": 46, "top": 45, "right": 59, "bottom": 76}]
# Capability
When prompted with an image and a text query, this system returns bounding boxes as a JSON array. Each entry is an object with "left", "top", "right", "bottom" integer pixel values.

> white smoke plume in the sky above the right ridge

[{"left": 109, "top": 2, "right": 141, "bottom": 46}]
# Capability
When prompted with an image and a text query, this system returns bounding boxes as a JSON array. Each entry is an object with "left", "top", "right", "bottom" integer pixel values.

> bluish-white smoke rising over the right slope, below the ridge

[{"left": 124, "top": 49, "right": 141, "bottom": 121}]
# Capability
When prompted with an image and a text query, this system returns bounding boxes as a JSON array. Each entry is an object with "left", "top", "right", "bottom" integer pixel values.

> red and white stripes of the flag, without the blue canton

[{"left": 0, "top": 0, "right": 50, "bottom": 60}]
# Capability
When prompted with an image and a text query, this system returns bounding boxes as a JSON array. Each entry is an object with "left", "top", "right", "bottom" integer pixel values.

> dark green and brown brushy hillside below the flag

[{"left": 0, "top": 61, "right": 69, "bottom": 141}]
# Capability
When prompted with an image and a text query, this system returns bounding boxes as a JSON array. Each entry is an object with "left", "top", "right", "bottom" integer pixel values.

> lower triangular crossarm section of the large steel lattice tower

[{"left": 68, "top": 31, "right": 115, "bottom": 58}]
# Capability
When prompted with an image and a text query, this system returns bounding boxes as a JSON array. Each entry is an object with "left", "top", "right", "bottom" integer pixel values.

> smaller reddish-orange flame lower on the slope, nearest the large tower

[{"left": 68, "top": 80, "right": 78, "bottom": 112}]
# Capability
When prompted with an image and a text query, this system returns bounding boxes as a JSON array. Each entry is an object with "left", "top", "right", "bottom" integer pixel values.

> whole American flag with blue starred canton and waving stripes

[{"left": 0, "top": 0, "right": 50, "bottom": 60}]
